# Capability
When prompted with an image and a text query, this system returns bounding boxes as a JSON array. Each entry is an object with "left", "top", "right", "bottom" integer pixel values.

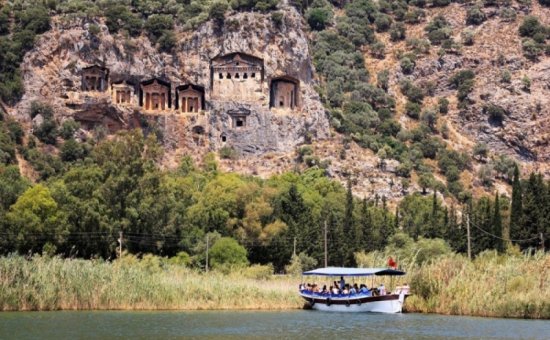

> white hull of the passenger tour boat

[{"left": 300, "top": 293, "right": 406, "bottom": 313}]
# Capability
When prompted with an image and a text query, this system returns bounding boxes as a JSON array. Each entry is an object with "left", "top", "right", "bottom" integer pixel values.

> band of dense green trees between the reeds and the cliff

[{"left": 0, "top": 112, "right": 550, "bottom": 271}]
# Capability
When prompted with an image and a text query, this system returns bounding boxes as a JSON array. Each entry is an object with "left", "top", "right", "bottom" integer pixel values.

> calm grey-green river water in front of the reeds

[{"left": 0, "top": 311, "right": 550, "bottom": 340}]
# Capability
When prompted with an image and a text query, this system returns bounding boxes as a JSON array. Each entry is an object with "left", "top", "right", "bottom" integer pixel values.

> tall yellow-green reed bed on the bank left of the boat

[{"left": 0, "top": 256, "right": 303, "bottom": 311}]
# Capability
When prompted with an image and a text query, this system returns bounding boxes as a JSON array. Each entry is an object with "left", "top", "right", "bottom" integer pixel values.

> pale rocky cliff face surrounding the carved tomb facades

[{"left": 14, "top": 3, "right": 329, "bottom": 155}]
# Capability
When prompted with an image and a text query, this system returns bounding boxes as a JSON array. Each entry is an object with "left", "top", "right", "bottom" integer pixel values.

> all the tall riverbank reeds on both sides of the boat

[{"left": 0, "top": 252, "right": 550, "bottom": 319}]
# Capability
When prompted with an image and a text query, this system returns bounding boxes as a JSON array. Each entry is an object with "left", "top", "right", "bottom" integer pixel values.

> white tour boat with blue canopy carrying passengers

[{"left": 300, "top": 267, "right": 409, "bottom": 313}]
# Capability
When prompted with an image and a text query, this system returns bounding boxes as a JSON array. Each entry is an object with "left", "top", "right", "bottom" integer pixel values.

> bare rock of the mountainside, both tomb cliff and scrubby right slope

[{"left": 4, "top": 1, "right": 550, "bottom": 200}]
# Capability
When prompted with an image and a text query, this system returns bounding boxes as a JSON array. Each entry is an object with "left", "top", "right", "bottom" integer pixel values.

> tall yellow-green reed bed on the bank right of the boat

[{"left": 358, "top": 251, "right": 550, "bottom": 319}]
